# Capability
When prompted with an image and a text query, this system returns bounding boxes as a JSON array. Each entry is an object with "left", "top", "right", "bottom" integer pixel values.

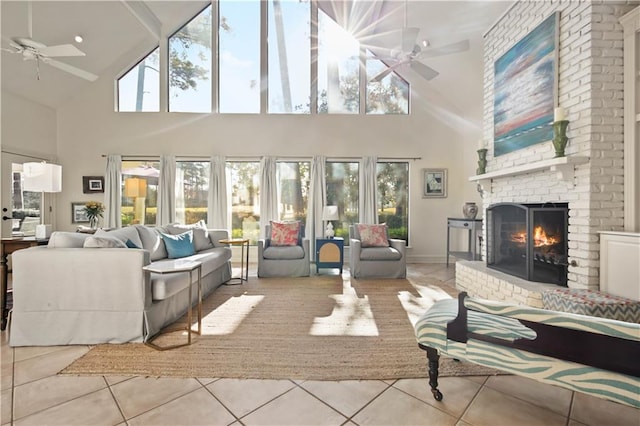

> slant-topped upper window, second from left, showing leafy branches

[{"left": 169, "top": 5, "right": 212, "bottom": 112}]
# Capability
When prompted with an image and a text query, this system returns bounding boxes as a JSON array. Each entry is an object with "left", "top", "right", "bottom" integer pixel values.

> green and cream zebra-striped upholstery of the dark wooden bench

[{"left": 415, "top": 297, "right": 640, "bottom": 408}]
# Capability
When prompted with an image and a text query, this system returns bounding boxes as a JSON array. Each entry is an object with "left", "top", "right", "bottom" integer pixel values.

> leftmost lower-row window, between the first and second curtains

[{"left": 120, "top": 161, "right": 160, "bottom": 226}]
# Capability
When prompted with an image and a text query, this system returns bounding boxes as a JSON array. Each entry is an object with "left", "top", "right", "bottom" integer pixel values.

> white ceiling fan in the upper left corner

[{"left": 2, "top": 2, "right": 98, "bottom": 81}]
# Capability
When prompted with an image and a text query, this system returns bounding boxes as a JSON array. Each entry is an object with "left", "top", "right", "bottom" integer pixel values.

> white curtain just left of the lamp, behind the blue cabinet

[{"left": 306, "top": 155, "right": 327, "bottom": 260}]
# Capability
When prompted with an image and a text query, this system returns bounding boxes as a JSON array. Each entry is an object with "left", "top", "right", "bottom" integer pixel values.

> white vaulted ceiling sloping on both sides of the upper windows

[{"left": 0, "top": 0, "right": 512, "bottom": 112}]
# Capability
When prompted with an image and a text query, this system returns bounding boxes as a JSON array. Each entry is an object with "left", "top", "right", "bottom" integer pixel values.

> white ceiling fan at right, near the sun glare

[{"left": 369, "top": 2, "right": 469, "bottom": 82}]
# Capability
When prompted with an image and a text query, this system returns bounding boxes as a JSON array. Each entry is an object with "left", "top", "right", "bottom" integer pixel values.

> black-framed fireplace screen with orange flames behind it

[{"left": 487, "top": 203, "right": 568, "bottom": 286}]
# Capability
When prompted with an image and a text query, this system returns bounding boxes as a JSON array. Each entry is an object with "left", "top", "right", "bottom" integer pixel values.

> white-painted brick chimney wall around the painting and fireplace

[{"left": 483, "top": 0, "right": 638, "bottom": 289}]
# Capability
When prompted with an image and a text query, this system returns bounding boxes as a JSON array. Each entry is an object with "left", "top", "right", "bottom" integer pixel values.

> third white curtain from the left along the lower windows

[{"left": 207, "top": 156, "right": 231, "bottom": 229}]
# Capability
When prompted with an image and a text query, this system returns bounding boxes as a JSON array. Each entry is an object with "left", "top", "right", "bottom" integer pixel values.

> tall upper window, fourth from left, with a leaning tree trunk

[{"left": 267, "top": 0, "right": 311, "bottom": 114}]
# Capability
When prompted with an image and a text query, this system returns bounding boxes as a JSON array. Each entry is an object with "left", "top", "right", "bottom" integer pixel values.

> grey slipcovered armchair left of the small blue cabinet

[{"left": 258, "top": 224, "right": 311, "bottom": 277}]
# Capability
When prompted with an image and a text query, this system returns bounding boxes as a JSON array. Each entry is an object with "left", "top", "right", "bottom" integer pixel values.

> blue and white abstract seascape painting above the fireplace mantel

[{"left": 493, "top": 12, "right": 560, "bottom": 156}]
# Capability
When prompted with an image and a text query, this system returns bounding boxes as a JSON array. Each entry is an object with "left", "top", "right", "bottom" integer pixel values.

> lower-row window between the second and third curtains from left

[{"left": 176, "top": 161, "right": 211, "bottom": 224}]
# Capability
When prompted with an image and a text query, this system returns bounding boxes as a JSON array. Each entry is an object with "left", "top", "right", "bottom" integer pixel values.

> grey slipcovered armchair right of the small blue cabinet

[{"left": 349, "top": 224, "right": 407, "bottom": 278}]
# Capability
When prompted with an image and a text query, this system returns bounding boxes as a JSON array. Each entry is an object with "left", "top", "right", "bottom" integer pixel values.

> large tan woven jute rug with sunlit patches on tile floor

[{"left": 61, "top": 275, "right": 504, "bottom": 380}]
